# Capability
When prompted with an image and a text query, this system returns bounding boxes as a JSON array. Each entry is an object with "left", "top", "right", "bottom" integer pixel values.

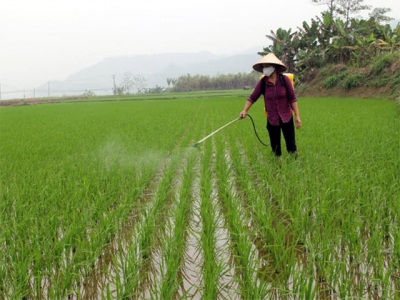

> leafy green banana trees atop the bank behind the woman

[{"left": 259, "top": 4, "right": 400, "bottom": 87}]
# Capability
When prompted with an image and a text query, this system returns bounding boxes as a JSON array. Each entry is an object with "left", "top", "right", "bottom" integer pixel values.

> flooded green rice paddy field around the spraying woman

[{"left": 0, "top": 94, "right": 400, "bottom": 299}]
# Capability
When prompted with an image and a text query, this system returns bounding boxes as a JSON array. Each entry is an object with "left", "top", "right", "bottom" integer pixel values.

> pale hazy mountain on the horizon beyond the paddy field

[{"left": 37, "top": 48, "right": 262, "bottom": 96}]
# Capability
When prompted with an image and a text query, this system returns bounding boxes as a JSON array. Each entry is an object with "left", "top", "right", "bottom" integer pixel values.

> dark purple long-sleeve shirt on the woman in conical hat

[{"left": 247, "top": 76, "right": 297, "bottom": 126}]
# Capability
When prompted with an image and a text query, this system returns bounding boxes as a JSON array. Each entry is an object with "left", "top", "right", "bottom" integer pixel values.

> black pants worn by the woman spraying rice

[{"left": 267, "top": 117, "right": 297, "bottom": 156}]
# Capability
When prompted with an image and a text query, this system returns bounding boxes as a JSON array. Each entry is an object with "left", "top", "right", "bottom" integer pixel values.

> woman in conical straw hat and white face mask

[{"left": 239, "top": 53, "right": 301, "bottom": 157}]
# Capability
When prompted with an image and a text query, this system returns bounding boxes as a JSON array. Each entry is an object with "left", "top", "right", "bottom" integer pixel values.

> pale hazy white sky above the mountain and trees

[{"left": 0, "top": 0, "right": 400, "bottom": 92}]
